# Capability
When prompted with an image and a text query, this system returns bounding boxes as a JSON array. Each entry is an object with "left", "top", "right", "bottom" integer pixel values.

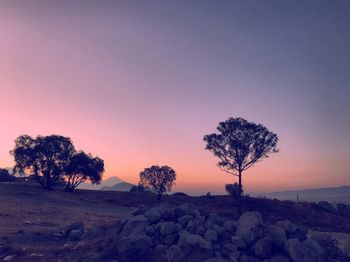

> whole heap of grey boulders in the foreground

[{"left": 108, "top": 204, "right": 349, "bottom": 262}]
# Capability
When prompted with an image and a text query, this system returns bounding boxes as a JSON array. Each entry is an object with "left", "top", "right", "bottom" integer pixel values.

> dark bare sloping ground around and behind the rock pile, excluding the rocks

[{"left": 0, "top": 183, "right": 350, "bottom": 261}]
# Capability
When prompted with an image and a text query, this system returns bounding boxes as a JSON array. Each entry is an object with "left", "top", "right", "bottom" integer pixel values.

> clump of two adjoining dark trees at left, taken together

[{"left": 10, "top": 135, "right": 104, "bottom": 191}]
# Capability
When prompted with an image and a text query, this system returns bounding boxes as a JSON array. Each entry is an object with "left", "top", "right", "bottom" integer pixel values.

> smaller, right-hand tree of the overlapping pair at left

[{"left": 64, "top": 151, "right": 104, "bottom": 191}]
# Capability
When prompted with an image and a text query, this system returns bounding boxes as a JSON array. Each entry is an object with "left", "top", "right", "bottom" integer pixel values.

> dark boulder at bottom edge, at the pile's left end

[{"left": 117, "top": 234, "right": 152, "bottom": 262}]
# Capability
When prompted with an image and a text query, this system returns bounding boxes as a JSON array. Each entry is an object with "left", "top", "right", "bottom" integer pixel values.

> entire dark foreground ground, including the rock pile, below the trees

[{"left": 0, "top": 184, "right": 350, "bottom": 262}]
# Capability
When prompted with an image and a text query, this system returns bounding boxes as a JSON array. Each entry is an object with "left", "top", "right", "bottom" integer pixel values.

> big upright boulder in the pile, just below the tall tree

[{"left": 236, "top": 212, "right": 263, "bottom": 244}]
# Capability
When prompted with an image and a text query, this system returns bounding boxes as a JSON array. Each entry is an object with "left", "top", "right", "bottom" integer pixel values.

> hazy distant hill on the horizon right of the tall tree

[{"left": 253, "top": 186, "right": 350, "bottom": 203}]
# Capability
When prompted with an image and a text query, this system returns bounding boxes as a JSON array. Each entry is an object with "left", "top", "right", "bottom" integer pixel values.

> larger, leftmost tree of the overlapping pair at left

[{"left": 10, "top": 135, "right": 75, "bottom": 189}]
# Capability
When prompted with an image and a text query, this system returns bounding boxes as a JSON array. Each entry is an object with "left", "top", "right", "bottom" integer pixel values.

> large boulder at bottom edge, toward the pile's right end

[{"left": 285, "top": 239, "right": 324, "bottom": 262}]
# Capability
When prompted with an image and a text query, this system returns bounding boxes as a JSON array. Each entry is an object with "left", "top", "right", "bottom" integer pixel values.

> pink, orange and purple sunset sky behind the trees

[{"left": 0, "top": 0, "right": 350, "bottom": 193}]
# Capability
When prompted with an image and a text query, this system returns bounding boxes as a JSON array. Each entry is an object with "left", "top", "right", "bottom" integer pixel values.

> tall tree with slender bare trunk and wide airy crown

[{"left": 204, "top": 117, "right": 278, "bottom": 196}]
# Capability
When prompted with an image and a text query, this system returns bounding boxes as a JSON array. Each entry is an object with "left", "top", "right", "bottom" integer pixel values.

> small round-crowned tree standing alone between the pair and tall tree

[{"left": 140, "top": 166, "right": 176, "bottom": 201}]
